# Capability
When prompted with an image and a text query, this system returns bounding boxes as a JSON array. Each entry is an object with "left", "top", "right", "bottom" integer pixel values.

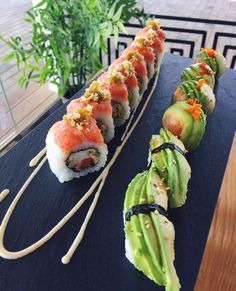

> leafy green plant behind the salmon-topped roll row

[{"left": 0, "top": 0, "right": 143, "bottom": 97}]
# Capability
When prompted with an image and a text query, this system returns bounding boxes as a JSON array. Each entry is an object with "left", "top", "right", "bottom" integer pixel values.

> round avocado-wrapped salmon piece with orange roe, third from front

[{"left": 162, "top": 99, "right": 206, "bottom": 151}]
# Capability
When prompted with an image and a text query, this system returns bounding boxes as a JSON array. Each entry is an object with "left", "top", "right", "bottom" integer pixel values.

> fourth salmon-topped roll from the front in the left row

[{"left": 109, "top": 58, "right": 141, "bottom": 110}]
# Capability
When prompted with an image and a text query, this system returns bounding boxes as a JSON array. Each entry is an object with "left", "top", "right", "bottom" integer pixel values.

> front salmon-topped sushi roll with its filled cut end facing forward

[{"left": 46, "top": 105, "right": 108, "bottom": 183}]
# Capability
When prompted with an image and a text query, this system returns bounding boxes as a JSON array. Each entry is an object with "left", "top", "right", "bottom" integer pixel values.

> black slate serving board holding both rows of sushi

[{"left": 0, "top": 54, "right": 236, "bottom": 291}]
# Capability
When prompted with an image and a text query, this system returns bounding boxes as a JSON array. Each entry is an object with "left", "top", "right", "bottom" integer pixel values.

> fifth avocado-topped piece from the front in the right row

[{"left": 181, "top": 63, "right": 215, "bottom": 89}]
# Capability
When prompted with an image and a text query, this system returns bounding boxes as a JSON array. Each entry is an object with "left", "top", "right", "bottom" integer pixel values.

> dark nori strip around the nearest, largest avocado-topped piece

[{"left": 125, "top": 203, "right": 168, "bottom": 221}]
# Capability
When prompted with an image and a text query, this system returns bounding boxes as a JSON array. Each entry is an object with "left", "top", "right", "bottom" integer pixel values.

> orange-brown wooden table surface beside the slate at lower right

[{"left": 195, "top": 135, "right": 236, "bottom": 291}]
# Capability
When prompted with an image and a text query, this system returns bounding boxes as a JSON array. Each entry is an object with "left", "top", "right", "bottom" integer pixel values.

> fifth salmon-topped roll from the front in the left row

[{"left": 122, "top": 48, "right": 148, "bottom": 96}]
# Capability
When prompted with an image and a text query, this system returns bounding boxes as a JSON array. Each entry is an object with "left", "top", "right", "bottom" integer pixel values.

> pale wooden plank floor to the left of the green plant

[{"left": 0, "top": 0, "right": 57, "bottom": 149}]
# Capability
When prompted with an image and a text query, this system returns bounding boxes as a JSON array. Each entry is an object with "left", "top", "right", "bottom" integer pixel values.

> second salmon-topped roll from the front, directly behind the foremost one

[{"left": 67, "top": 81, "right": 114, "bottom": 142}]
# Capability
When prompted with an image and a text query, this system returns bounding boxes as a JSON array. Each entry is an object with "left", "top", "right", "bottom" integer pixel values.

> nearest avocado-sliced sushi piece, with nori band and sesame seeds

[{"left": 124, "top": 168, "right": 180, "bottom": 291}]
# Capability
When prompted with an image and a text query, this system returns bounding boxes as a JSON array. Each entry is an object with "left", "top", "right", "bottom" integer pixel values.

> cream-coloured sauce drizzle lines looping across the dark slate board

[{"left": 0, "top": 75, "right": 158, "bottom": 264}]
